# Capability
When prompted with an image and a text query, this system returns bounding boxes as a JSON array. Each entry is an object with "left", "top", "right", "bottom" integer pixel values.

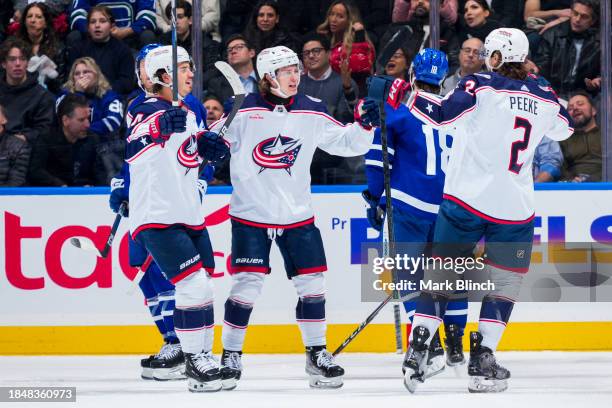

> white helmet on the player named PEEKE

[{"left": 484, "top": 28, "right": 529, "bottom": 69}]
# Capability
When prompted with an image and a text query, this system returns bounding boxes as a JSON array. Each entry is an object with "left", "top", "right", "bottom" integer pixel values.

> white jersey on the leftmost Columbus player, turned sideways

[{"left": 126, "top": 98, "right": 204, "bottom": 237}]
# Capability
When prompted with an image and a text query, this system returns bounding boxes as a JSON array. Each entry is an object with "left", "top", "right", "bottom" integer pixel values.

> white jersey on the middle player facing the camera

[{"left": 211, "top": 94, "right": 374, "bottom": 228}]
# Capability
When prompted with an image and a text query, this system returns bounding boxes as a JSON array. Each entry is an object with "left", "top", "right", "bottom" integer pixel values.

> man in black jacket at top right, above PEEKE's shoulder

[{"left": 534, "top": 0, "right": 600, "bottom": 99}]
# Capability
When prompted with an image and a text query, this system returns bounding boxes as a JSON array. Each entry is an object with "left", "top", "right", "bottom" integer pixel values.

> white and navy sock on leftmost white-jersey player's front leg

[{"left": 174, "top": 270, "right": 215, "bottom": 354}]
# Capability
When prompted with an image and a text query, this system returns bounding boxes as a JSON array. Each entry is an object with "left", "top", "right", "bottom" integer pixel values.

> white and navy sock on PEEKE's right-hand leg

[{"left": 478, "top": 295, "right": 514, "bottom": 352}]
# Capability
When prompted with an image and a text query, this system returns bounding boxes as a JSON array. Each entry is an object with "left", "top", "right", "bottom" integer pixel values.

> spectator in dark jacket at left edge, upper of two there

[{"left": 0, "top": 37, "right": 53, "bottom": 145}]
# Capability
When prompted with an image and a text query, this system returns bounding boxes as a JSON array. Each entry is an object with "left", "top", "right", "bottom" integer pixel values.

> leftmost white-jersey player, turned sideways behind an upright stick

[{"left": 126, "top": 46, "right": 228, "bottom": 392}]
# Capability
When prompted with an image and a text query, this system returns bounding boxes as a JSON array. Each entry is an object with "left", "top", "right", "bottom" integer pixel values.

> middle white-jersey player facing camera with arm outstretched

[{"left": 211, "top": 46, "right": 379, "bottom": 389}]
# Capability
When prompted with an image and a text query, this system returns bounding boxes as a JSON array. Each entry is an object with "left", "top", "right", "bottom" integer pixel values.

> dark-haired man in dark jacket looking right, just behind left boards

[{"left": 29, "top": 95, "right": 106, "bottom": 187}]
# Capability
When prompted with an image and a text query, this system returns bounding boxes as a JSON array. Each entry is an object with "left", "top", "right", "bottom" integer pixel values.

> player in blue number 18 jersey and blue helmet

[{"left": 363, "top": 48, "right": 467, "bottom": 377}]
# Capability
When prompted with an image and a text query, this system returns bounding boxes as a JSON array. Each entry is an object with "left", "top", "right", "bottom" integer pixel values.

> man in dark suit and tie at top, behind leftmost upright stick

[{"left": 160, "top": 0, "right": 221, "bottom": 77}]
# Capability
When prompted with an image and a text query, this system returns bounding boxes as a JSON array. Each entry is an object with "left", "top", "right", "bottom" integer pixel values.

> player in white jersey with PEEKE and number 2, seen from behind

[{"left": 404, "top": 28, "right": 573, "bottom": 392}]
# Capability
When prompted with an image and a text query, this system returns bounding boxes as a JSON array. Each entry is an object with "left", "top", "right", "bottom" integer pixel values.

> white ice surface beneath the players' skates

[{"left": 0, "top": 352, "right": 612, "bottom": 408}]
